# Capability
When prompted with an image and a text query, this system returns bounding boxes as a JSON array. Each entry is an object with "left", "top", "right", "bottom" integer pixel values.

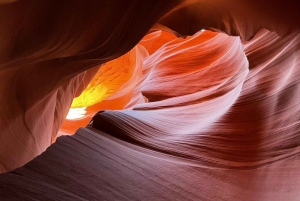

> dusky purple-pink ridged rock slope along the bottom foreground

[{"left": 0, "top": 128, "right": 300, "bottom": 201}]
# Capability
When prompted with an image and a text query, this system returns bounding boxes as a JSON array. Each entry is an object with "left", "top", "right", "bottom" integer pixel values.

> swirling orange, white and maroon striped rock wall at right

[{"left": 92, "top": 30, "right": 300, "bottom": 169}]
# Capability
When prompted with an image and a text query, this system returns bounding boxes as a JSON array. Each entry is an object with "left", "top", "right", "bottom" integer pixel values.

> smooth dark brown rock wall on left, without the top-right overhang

[{"left": 0, "top": 0, "right": 178, "bottom": 172}]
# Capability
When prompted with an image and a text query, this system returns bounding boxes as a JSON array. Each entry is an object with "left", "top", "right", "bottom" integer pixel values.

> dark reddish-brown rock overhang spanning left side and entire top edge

[{"left": 0, "top": 0, "right": 300, "bottom": 172}]
